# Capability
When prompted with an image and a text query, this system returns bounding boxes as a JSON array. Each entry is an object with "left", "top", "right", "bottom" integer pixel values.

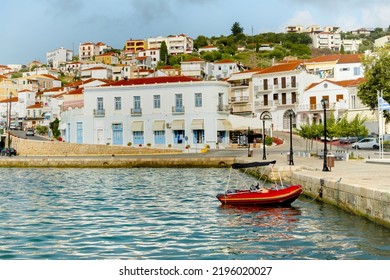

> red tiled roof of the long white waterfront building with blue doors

[{"left": 102, "top": 76, "right": 201, "bottom": 87}]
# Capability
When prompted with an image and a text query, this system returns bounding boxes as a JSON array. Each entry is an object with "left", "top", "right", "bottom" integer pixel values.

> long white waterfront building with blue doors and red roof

[{"left": 61, "top": 76, "right": 231, "bottom": 150}]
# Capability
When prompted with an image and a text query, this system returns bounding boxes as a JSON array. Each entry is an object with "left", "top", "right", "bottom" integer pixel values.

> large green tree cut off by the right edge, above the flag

[{"left": 357, "top": 44, "right": 390, "bottom": 122}]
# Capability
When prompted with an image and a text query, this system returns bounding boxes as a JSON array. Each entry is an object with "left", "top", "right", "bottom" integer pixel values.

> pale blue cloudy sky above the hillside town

[{"left": 0, "top": 0, "right": 390, "bottom": 65}]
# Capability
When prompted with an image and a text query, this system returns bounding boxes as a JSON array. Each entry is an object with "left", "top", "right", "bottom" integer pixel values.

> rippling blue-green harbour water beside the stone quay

[{"left": 0, "top": 168, "right": 390, "bottom": 260}]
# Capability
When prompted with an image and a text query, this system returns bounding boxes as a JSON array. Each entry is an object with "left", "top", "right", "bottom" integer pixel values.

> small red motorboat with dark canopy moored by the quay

[{"left": 217, "top": 161, "right": 302, "bottom": 206}]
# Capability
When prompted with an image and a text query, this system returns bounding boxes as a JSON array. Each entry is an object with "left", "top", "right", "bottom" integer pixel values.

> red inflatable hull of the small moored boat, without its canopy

[{"left": 217, "top": 185, "right": 302, "bottom": 206}]
